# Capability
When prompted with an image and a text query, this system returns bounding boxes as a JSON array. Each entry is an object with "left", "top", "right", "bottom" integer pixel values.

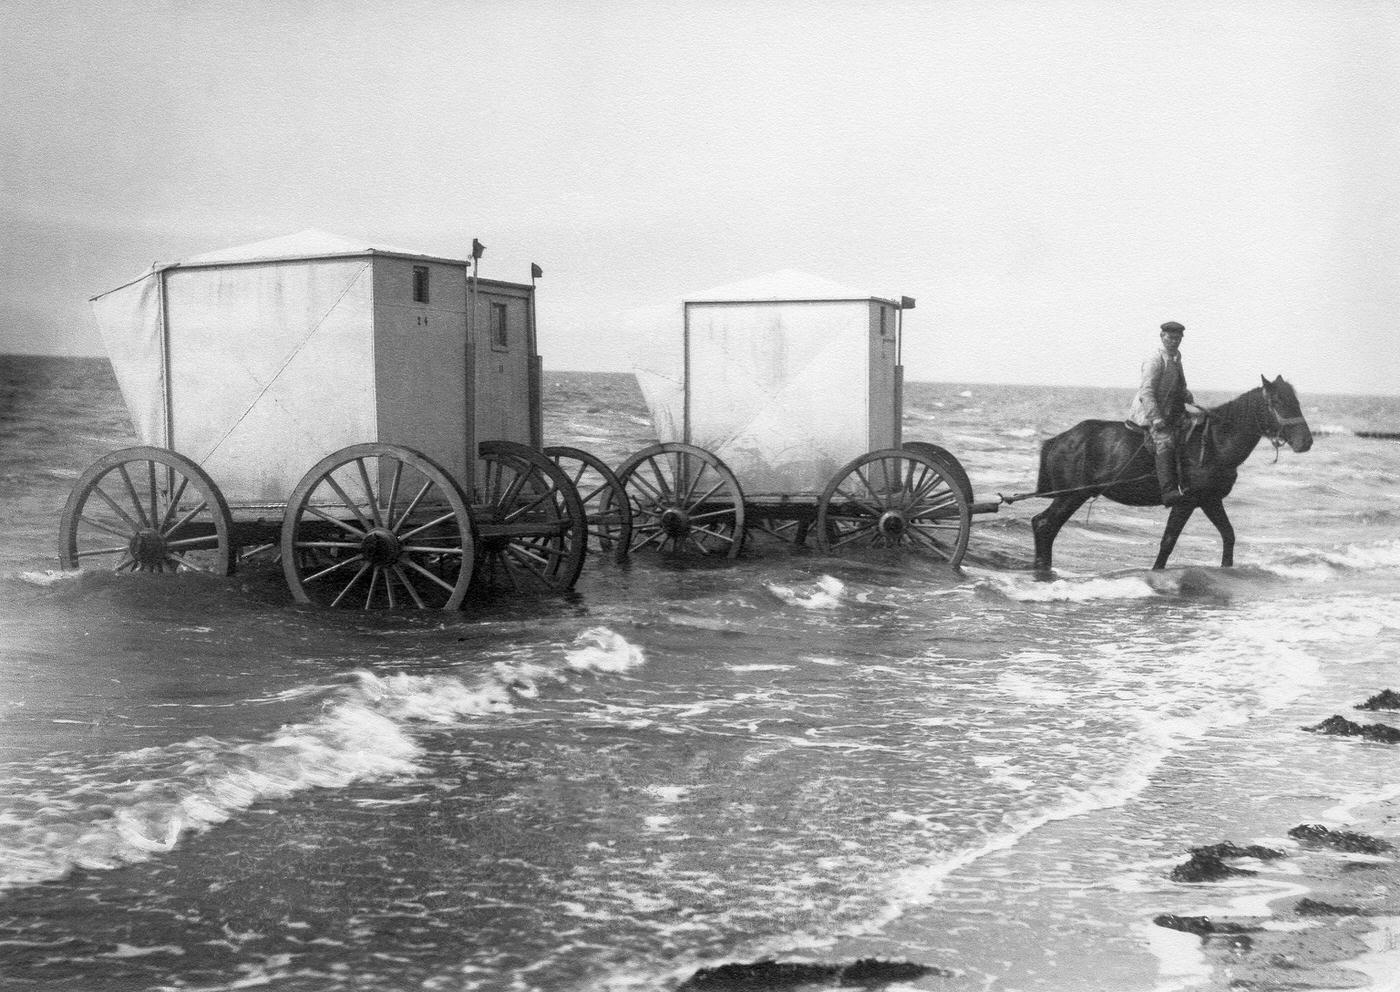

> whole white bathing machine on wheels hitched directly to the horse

[{"left": 616, "top": 270, "right": 997, "bottom": 567}]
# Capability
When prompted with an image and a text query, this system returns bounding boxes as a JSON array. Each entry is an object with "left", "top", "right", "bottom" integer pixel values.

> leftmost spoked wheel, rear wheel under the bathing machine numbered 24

[{"left": 59, "top": 446, "right": 234, "bottom": 575}]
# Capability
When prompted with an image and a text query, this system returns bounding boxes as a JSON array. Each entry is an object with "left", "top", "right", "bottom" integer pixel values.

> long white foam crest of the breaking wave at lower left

[{"left": 0, "top": 627, "right": 643, "bottom": 891}]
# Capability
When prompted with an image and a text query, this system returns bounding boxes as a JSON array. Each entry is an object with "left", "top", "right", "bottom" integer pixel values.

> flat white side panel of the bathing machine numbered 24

[{"left": 165, "top": 257, "right": 378, "bottom": 504}]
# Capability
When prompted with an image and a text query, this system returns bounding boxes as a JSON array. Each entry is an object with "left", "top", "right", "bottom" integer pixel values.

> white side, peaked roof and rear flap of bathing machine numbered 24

[{"left": 92, "top": 231, "right": 461, "bottom": 505}]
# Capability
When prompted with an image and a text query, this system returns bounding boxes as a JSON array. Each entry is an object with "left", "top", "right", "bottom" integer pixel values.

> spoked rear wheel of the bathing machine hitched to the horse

[{"left": 617, "top": 442, "right": 743, "bottom": 558}]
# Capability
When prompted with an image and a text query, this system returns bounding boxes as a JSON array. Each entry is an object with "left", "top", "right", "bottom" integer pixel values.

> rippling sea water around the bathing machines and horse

[{"left": 0, "top": 362, "right": 1400, "bottom": 991}]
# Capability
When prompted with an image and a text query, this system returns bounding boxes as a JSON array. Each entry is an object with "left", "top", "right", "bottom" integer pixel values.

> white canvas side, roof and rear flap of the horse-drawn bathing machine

[{"left": 627, "top": 270, "right": 893, "bottom": 495}]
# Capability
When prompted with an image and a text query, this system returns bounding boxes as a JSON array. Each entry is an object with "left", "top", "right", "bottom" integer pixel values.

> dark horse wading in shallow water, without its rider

[{"left": 1030, "top": 375, "right": 1312, "bottom": 572}]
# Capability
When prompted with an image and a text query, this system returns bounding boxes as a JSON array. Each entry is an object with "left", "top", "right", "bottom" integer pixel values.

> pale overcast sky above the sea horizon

[{"left": 0, "top": 0, "right": 1400, "bottom": 395}]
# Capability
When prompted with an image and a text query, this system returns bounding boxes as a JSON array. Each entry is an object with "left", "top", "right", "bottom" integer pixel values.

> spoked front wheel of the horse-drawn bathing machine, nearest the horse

[{"left": 816, "top": 448, "right": 972, "bottom": 568}]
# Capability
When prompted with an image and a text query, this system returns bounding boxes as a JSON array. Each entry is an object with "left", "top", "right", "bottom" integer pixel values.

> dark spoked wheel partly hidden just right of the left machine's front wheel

[{"left": 473, "top": 441, "right": 588, "bottom": 592}]
